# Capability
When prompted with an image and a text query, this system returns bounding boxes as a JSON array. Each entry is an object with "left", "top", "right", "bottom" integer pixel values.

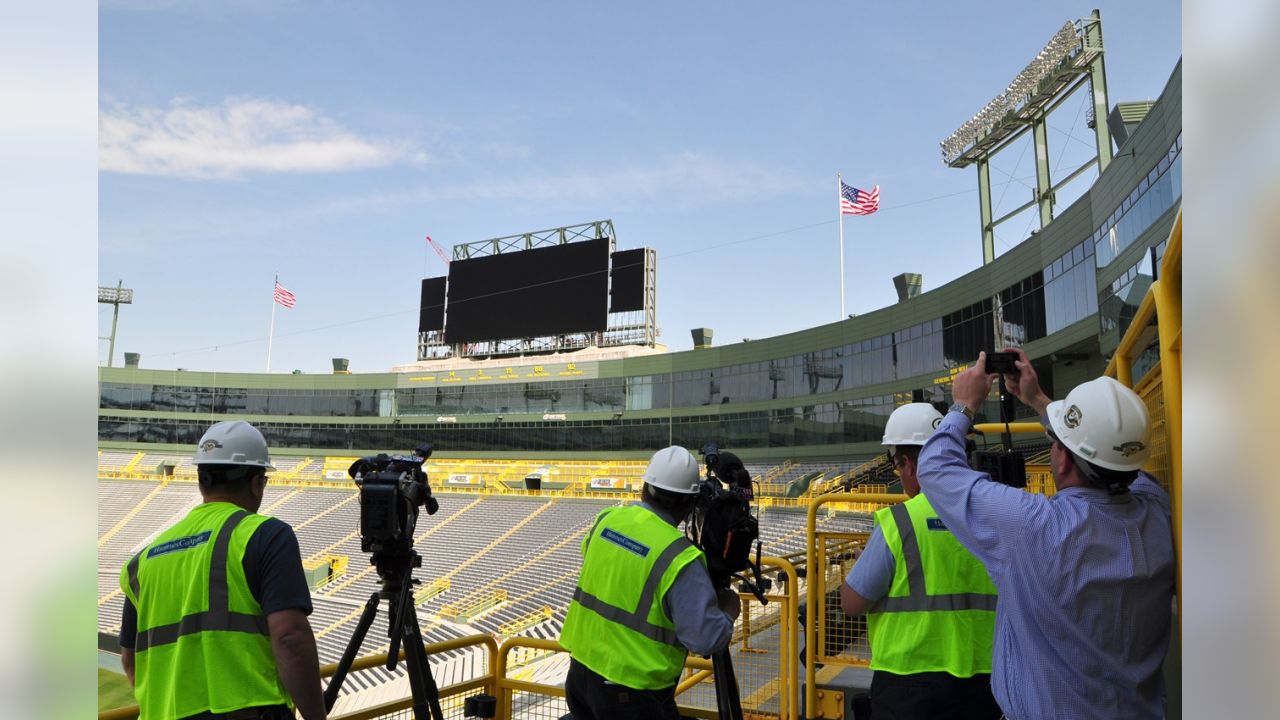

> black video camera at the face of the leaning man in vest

[{"left": 687, "top": 442, "right": 769, "bottom": 603}]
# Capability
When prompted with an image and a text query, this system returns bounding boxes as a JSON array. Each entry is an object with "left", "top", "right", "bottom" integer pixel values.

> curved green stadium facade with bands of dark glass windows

[{"left": 99, "top": 63, "right": 1181, "bottom": 460}]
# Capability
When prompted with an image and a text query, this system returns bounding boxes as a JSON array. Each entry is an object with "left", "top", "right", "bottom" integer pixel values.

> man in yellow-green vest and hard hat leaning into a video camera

[{"left": 561, "top": 446, "right": 741, "bottom": 720}]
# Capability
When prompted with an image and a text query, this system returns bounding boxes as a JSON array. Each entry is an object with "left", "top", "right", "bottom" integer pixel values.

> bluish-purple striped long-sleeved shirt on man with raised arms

[{"left": 919, "top": 413, "right": 1175, "bottom": 720}]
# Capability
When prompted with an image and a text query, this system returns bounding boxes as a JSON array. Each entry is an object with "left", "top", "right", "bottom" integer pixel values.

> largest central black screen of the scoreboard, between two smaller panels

[{"left": 444, "top": 238, "right": 609, "bottom": 343}]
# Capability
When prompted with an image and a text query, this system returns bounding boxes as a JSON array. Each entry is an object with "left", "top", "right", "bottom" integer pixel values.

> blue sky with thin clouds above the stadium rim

[{"left": 99, "top": 0, "right": 1181, "bottom": 373}]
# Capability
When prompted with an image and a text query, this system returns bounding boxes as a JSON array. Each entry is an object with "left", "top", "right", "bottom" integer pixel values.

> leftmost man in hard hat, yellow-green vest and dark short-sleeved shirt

[{"left": 120, "top": 420, "right": 326, "bottom": 720}]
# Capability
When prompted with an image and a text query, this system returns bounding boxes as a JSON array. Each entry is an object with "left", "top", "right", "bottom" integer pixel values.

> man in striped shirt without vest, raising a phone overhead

[{"left": 919, "top": 350, "right": 1175, "bottom": 720}]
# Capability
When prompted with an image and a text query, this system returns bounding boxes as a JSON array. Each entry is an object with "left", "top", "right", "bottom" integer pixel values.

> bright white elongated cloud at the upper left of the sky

[{"left": 99, "top": 97, "right": 426, "bottom": 179}]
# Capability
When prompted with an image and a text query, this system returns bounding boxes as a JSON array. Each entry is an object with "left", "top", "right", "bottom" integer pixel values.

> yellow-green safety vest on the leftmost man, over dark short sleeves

[{"left": 120, "top": 502, "right": 292, "bottom": 720}]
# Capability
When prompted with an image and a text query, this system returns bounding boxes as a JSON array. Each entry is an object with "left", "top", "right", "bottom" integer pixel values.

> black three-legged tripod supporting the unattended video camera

[{"left": 324, "top": 547, "right": 444, "bottom": 720}]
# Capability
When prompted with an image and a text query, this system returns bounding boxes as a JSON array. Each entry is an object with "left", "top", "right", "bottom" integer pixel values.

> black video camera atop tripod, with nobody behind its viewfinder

[{"left": 347, "top": 443, "right": 440, "bottom": 553}]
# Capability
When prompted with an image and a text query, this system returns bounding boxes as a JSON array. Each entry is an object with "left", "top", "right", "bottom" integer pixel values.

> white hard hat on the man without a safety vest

[{"left": 1046, "top": 377, "right": 1151, "bottom": 470}]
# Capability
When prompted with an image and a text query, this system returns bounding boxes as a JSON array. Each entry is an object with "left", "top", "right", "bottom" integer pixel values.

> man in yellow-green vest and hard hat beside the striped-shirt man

[{"left": 840, "top": 402, "right": 1000, "bottom": 720}]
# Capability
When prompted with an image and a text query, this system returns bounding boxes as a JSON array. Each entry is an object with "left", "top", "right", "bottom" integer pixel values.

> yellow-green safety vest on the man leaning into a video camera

[{"left": 561, "top": 505, "right": 707, "bottom": 691}]
